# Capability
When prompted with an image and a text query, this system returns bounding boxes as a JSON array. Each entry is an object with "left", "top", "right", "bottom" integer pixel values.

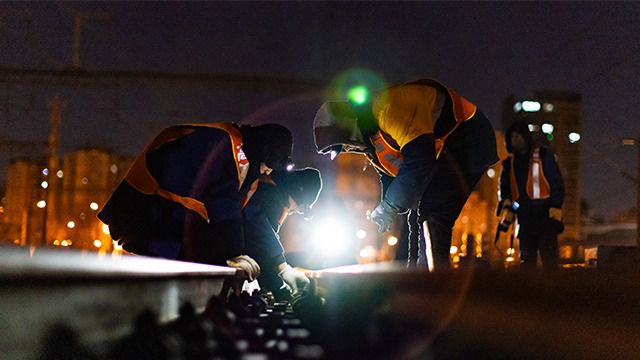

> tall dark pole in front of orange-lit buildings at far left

[{"left": 41, "top": 96, "right": 65, "bottom": 246}]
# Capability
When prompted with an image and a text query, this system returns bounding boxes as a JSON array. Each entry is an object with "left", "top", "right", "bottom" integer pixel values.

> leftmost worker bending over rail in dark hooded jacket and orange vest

[{"left": 98, "top": 123, "right": 293, "bottom": 278}]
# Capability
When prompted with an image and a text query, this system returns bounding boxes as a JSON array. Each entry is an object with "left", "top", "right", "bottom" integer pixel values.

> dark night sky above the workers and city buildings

[{"left": 0, "top": 2, "right": 640, "bottom": 218}]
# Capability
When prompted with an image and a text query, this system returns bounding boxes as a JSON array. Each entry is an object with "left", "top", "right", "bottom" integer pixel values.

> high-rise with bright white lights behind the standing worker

[{"left": 503, "top": 91, "right": 582, "bottom": 260}]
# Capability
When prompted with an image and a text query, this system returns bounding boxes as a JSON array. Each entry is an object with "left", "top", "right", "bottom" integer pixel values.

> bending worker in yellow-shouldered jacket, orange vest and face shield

[{"left": 314, "top": 79, "right": 498, "bottom": 269}]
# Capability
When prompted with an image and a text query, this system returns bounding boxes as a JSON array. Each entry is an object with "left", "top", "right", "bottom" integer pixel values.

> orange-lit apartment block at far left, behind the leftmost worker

[{"left": 2, "top": 147, "right": 132, "bottom": 251}]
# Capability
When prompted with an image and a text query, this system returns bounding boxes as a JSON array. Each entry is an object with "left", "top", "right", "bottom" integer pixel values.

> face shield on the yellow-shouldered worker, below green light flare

[{"left": 313, "top": 101, "right": 368, "bottom": 158}]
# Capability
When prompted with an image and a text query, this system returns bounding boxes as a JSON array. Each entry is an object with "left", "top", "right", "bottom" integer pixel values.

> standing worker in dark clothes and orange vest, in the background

[{"left": 498, "top": 121, "right": 564, "bottom": 269}]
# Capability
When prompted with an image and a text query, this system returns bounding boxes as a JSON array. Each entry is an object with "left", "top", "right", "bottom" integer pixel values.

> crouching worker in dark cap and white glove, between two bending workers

[{"left": 244, "top": 168, "right": 322, "bottom": 300}]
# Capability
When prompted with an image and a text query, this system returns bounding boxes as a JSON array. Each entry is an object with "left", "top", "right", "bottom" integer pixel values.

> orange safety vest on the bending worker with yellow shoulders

[{"left": 368, "top": 79, "right": 478, "bottom": 177}]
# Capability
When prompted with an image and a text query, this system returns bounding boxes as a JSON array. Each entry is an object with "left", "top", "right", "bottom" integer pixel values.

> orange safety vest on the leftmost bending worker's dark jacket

[{"left": 125, "top": 123, "right": 252, "bottom": 221}]
